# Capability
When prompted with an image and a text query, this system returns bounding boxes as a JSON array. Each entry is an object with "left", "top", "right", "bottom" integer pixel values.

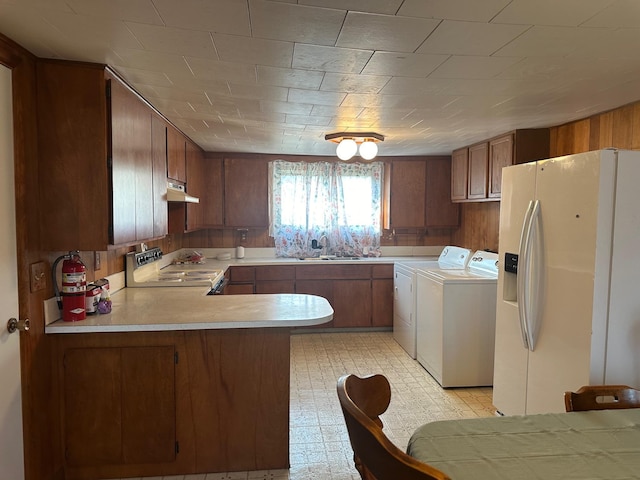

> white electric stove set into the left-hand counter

[{"left": 125, "top": 248, "right": 224, "bottom": 293}]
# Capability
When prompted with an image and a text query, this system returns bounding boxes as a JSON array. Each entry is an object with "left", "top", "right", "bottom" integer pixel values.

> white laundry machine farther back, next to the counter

[{"left": 393, "top": 245, "right": 471, "bottom": 359}]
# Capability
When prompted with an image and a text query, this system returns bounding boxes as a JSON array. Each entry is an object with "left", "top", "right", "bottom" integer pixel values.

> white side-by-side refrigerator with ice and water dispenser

[{"left": 493, "top": 150, "right": 640, "bottom": 415}]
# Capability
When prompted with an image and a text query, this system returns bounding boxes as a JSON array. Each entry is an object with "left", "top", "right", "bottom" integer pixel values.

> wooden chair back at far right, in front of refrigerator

[{"left": 564, "top": 385, "right": 640, "bottom": 412}]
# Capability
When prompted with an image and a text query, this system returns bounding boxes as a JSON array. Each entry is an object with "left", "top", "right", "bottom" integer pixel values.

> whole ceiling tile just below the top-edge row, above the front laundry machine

[{"left": 417, "top": 20, "right": 528, "bottom": 56}]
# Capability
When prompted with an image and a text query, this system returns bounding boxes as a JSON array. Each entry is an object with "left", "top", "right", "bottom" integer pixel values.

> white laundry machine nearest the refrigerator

[{"left": 416, "top": 250, "right": 498, "bottom": 388}]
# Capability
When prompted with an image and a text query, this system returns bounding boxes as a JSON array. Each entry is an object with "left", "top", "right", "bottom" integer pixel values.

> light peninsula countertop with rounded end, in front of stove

[{"left": 45, "top": 287, "right": 333, "bottom": 333}]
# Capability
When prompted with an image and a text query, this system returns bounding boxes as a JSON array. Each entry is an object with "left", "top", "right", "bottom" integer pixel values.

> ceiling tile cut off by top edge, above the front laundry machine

[{"left": 398, "top": 0, "right": 511, "bottom": 22}]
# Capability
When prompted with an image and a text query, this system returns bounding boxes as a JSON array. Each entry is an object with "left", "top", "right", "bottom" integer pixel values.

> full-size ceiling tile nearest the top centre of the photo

[{"left": 249, "top": 0, "right": 346, "bottom": 45}]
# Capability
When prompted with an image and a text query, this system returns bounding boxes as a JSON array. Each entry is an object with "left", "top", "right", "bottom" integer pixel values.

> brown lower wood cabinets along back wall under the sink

[{"left": 225, "top": 264, "right": 393, "bottom": 328}]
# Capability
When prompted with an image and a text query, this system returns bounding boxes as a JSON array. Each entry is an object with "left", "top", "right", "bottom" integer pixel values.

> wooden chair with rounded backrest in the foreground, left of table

[{"left": 338, "top": 375, "right": 449, "bottom": 480}]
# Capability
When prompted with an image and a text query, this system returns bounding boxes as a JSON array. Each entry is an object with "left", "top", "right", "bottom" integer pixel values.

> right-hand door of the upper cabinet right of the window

[{"left": 425, "top": 157, "right": 460, "bottom": 228}]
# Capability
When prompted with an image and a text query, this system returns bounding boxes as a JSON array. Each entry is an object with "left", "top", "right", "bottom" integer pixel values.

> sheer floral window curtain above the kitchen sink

[{"left": 269, "top": 160, "right": 384, "bottom": 257}]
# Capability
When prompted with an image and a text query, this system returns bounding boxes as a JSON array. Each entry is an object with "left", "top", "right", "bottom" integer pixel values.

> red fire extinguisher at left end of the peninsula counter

[{"left": 52, "top": 251, "right": 87, "bottom": 322}]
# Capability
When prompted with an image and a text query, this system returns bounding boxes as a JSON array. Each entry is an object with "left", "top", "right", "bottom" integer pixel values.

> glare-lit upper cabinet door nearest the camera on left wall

[{"left": 109, "top": 78, "right": 154, "bottom": 245}]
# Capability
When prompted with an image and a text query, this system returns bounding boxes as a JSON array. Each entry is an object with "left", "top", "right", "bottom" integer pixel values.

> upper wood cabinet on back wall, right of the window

[{"left": 385, "top": 157, "right": 459, "bottom": 228}]
